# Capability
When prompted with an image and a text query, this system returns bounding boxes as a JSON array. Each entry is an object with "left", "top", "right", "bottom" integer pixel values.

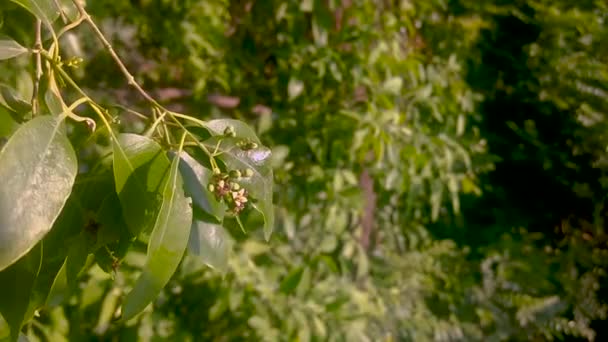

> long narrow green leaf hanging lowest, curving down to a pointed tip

[{"left": 123, "top": 150, "right": 192, "bottom": 321}]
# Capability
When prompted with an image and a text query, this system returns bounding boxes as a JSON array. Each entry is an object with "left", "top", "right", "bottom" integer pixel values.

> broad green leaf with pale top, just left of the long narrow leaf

[{"left": 113, "top": 134, "right": 170, "bottom": 236}]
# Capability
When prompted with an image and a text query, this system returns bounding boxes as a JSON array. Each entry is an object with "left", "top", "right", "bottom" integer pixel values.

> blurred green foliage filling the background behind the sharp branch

[{"left": 0, "top": 0, "right": 608, "bottom": 341}]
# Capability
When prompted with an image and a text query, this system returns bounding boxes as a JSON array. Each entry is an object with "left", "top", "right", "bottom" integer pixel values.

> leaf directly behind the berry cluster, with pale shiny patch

[{"left": 205, "top": 137, "right": 274, "bottom": 240}]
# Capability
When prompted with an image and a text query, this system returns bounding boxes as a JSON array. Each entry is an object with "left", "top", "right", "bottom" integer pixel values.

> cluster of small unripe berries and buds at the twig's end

[{"left": 207, "top": 169, "right": 253, "bottom": 214}]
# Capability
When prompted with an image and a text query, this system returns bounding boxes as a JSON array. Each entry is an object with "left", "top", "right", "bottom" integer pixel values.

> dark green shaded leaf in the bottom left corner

[{"left": 0, "top": 245, "right": 42, "bottom": 341}]
